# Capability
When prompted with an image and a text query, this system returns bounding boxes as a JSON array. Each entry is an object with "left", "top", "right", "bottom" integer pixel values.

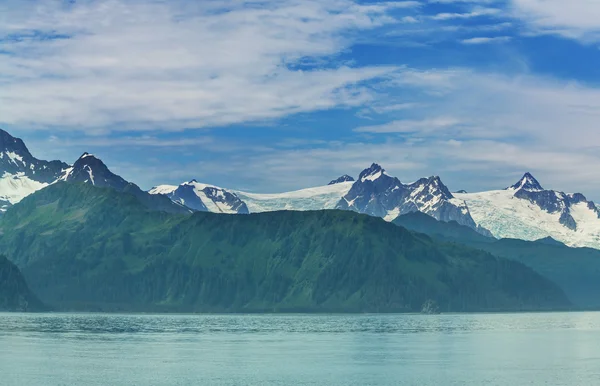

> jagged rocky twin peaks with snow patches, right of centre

[{"left": 336, "top": 164, "right": 489, "bottom": 235}]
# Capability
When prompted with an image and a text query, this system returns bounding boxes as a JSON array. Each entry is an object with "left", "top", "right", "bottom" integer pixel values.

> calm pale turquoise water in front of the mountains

[{"left": 0, "top": 313, "right": 600, "bottom": 386}]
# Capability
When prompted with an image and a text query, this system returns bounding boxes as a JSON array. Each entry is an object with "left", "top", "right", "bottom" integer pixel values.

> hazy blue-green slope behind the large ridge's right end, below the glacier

[{"left": 394, "top": 213, "right": 600, "bottom": 308}]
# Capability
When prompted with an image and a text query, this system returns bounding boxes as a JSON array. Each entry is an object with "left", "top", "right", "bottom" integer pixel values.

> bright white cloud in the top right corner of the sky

[{"left": 510, "top": 0, "right": 600, "bottom": 42}]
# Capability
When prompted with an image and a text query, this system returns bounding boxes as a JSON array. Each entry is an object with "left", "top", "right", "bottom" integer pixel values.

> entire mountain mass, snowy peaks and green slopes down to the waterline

[{"left": 0, "top": 128, "right": 600, "bottom": 312}]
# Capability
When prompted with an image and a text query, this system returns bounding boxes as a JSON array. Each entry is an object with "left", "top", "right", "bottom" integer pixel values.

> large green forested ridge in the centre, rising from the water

[{"left": 0, "top": 183, "right": 569, "bottom": 312}]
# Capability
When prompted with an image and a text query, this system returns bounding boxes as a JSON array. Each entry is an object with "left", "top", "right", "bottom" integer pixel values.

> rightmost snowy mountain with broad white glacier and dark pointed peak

[{"left": 455, "top": 173, "right": 600, "bottom": 248}]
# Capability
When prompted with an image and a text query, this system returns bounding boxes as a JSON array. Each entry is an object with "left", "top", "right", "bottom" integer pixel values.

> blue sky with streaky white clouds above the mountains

[{"left": 0, "top": 0, "right": 600, "bottom": 195}]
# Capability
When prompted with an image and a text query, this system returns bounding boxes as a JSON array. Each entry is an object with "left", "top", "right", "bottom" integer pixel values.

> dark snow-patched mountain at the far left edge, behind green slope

[{"left": 0, "top": 130, "right": 69, "bottom": 212}]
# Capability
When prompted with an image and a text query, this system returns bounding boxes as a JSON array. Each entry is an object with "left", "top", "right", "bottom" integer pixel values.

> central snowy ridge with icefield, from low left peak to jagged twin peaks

[{"left": 149, "top": 164, "right": 491, "bottom": 236}]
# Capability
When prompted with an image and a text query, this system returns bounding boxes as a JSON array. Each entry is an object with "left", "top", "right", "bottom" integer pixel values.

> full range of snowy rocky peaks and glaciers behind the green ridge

[{"left": 0, "top": 130, "right": 600, "bottom": 249}]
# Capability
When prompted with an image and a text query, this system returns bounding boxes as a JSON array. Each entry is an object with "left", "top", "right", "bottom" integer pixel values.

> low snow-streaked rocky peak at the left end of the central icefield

[{"left": 149, "top": 180, "right": 250, "bottom": 214}]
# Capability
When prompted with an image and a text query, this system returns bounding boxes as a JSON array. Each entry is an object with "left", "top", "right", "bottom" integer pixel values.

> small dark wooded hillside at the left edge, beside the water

[{"left": 0, "top": 256, "right": 44, "bottom": 311}]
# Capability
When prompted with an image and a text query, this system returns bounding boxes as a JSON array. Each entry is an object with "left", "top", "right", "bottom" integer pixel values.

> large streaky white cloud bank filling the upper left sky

[{"left": 0, "top": 0, "right": 408, "bottom": 130}]
